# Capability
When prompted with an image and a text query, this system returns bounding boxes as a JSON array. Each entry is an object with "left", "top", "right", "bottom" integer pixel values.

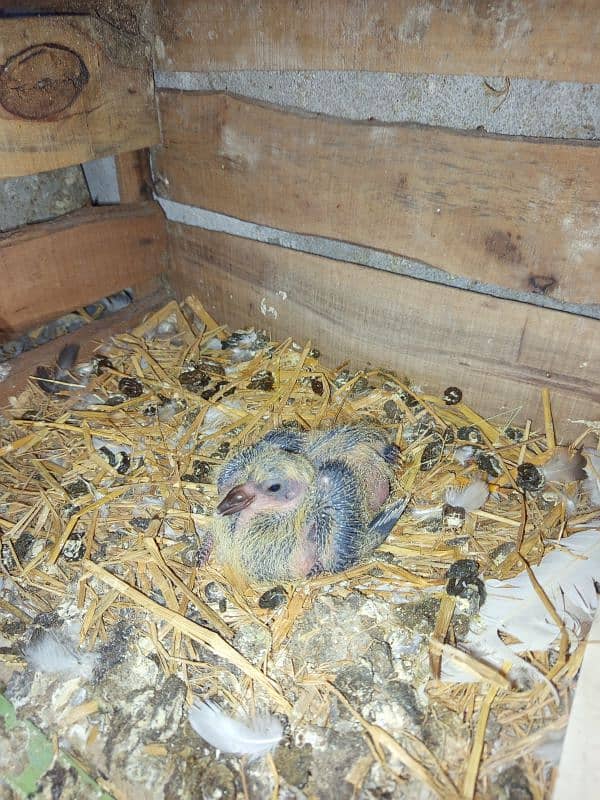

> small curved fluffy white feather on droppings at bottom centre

[{"left": 188, "top": 700, "right": 283, "bottom": 759}]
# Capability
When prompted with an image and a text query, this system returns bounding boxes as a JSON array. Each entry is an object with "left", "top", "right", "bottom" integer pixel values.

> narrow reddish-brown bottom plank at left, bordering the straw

[{"left": 0, "top": 278, "right": 172, "bottom": 409}]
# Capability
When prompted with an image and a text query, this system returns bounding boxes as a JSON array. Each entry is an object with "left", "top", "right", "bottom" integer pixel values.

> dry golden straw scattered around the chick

[{"left": 0, "top": 297, "right": 595, "bottom": 800}]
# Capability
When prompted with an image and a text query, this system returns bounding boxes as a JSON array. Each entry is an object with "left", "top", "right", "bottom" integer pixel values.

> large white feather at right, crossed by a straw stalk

[{"left": 442, "top": 530, "right": 600, "bottom": 682}]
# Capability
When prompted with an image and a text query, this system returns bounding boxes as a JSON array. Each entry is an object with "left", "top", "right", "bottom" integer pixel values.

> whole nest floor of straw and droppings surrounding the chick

[{"left": 0, "top": 298, "right": 600, "bottom": 800}]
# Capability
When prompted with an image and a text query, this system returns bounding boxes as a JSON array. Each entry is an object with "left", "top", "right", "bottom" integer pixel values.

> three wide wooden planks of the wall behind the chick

[{"left": 153, "top": 0, "right": 600, "bottom": 428}]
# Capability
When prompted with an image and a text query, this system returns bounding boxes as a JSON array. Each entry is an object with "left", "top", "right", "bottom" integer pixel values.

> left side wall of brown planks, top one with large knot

[{"left": 0, "top": 3, "right": 167, "bottom": 350}]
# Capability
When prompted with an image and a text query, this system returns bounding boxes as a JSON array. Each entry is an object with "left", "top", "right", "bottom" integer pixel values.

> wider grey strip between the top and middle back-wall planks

[{"left": 155, "top": 70, "right": 600, "bottom": 140}]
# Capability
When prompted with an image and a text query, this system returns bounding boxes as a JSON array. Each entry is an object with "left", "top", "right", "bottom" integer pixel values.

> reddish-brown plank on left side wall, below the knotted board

[{"left": 0, "top": 203, "right": 166, "bottom": 338}]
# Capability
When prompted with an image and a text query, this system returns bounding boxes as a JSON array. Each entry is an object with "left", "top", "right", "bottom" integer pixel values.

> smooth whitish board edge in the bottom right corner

[{"left": 553, "top": 611, "right": 600, "bottom": 800}]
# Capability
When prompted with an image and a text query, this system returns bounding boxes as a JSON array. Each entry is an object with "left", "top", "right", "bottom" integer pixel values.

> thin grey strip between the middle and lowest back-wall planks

[{"left": 156, "top": 196, "right": 600, "bottom": 319}]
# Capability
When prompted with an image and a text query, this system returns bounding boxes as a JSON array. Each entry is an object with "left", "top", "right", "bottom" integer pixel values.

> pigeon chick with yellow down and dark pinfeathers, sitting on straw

[{"left": 214, "top": 426, "right": 407, "bottom": 581}]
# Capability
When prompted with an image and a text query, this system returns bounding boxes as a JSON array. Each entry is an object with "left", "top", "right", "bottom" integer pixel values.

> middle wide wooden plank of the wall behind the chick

[{"left": 156, "top": 91, "right": 600, "bottom": 303}]
